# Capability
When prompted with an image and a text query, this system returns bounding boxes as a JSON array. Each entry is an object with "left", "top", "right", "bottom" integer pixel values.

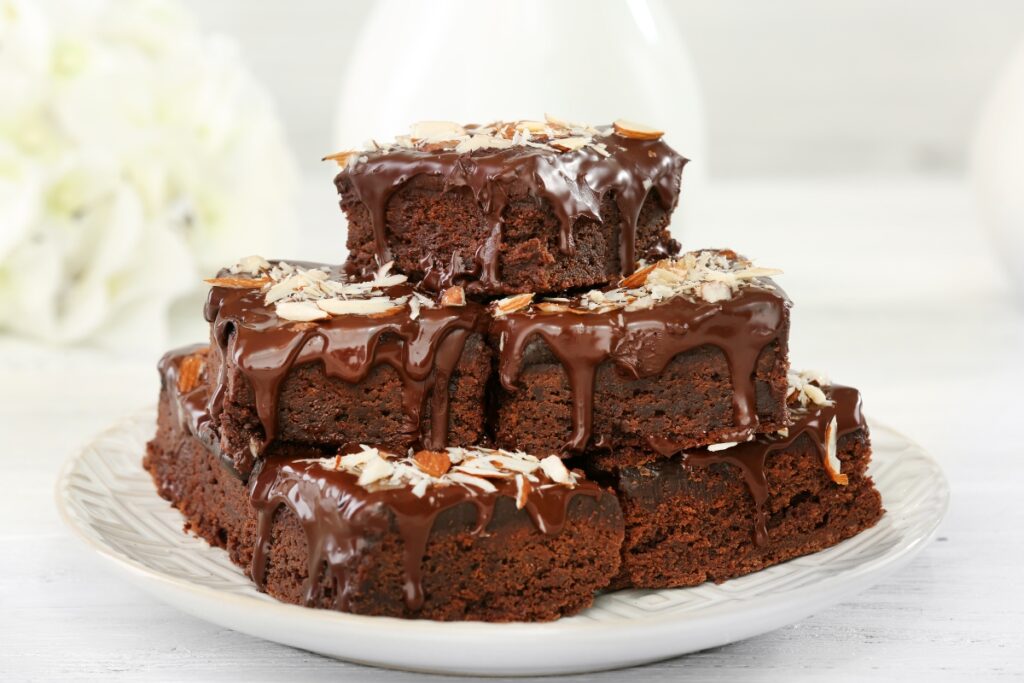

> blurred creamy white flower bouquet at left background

[{"left": 0, "top": 0, "right": 295, "bottom": 349}]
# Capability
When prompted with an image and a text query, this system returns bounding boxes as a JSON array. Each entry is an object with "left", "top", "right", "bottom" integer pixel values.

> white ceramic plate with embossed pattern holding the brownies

[{"left": 56, "top": 411, "right": 949, "bottom": 675}]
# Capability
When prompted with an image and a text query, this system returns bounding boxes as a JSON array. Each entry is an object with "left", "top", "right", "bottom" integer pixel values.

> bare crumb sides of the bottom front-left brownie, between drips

[{"left": 143, "top": 391, "right": 624, "bottom": 622}]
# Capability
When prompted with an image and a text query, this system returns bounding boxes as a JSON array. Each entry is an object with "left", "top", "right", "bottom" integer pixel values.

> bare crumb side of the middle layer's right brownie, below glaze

[{"left": 496, "top": 342, "right": 788, "bottom": 470}]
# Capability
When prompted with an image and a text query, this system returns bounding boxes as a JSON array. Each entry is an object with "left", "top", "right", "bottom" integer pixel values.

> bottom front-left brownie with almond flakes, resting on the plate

[{"left": 144, "top": 355, "right": 624, "bottom": 622}]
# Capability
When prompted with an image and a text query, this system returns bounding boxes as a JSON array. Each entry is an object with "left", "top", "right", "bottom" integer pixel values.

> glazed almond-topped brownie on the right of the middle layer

[{"left": 490, "top": 251, "right": 790, "bottom": 468}]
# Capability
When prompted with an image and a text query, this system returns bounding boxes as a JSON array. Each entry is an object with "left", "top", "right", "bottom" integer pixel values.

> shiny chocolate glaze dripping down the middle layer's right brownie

[{"left": 492, "top": 286, "right": 791, "bottom": 457}]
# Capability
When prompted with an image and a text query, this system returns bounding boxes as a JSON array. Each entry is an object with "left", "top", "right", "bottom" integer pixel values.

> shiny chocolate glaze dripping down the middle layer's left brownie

[{"left": 205, "top": 264, "right": 486, "bottom": 456}]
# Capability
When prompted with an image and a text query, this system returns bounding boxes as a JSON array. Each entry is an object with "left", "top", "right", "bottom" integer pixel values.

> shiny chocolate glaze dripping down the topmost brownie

[{"left": 335, "top": 128, "right": 687, "bottom": 293}]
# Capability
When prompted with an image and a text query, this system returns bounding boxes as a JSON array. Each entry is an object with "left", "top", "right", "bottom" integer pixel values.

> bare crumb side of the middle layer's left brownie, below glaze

[{"left": 210, "top": 333, "right": 490, "bottom": 474}]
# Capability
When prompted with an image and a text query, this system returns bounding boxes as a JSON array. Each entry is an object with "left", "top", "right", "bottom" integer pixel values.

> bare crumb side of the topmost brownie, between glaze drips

[{"left": 338, "top": 175, "right": 678, "bottom": 295}]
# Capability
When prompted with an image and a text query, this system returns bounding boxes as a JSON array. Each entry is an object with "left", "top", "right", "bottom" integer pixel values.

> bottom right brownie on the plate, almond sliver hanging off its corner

[{"left": 613, "top": 377, "right": 883, "bottom": 588}]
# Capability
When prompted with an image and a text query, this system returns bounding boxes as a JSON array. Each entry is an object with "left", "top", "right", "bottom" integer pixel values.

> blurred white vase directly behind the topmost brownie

[{"left": 336, "top": 0, "right": 707, "bottom": 241}]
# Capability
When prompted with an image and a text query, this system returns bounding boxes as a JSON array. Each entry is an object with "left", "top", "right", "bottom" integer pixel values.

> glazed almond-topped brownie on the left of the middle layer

[{"left": 206, "top": 258, "right": 492, "bottom": 473}]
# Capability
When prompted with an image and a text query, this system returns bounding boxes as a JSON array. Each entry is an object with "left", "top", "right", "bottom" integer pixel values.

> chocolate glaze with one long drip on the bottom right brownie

[{"left": 683, "top": 385, "right": 866, "bottom": 548}]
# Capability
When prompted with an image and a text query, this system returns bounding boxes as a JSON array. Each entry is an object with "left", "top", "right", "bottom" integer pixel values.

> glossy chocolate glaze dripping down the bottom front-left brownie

[{"left": 250, "top": 459, "right": 607, "bottom": 612}]
